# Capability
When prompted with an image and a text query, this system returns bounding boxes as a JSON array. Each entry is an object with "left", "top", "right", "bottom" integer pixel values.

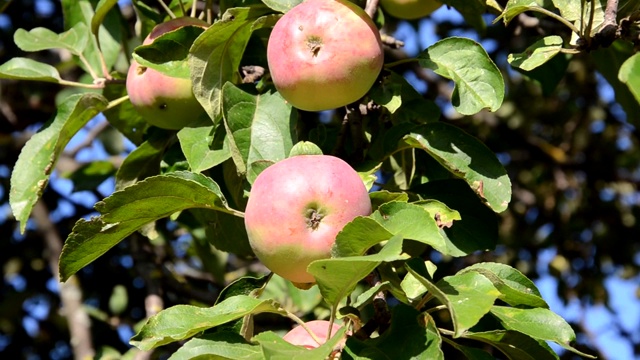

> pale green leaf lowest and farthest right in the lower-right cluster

[{"left": 491, "top": 306, "right": 592, "bottom": 354}]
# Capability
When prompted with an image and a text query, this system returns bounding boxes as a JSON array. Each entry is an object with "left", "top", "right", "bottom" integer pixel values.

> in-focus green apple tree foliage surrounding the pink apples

[{"left": 0, "top": 0, "right": 640, "bottom": 359}]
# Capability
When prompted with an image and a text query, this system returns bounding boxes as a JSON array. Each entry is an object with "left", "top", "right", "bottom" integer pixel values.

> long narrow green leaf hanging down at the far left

[{"left": 9, "top": 93, "right": 107, "bottom": 232}]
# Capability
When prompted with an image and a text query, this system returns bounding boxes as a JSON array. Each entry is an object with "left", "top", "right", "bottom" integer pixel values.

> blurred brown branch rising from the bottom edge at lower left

[{"left": 33, "top": 199, "right": 95, "bottom": 360}]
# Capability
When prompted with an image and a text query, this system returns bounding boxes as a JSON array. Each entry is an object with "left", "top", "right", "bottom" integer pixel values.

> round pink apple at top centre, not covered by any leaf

[{"left": 267, "top": 0, "right": 384, "bottom": 111}]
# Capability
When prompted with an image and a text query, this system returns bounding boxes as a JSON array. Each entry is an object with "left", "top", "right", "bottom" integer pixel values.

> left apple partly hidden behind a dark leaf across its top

[{"left": 126, "top": 17, "right": 209, "bottom": 130}]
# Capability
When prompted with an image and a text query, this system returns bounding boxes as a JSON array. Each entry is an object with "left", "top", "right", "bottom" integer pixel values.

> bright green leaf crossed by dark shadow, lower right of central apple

[{"left": 406, "top": 259, "right": 500, "bottom": 337}]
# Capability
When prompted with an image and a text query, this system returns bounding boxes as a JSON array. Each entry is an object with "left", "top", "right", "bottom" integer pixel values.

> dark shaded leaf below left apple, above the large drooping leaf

[{"left": 116, "top": 129, "right": 173, "bottom": 190}]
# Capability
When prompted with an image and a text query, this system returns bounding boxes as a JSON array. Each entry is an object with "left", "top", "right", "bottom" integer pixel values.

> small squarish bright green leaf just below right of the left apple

[{"left": 178, "top": 124, "right": 231, "bottom": 172}]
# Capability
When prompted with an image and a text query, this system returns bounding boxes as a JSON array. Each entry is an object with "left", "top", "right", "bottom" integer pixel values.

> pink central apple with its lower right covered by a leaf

[{"left": 244, "top": 155, "right": 371, "bottom": 288}]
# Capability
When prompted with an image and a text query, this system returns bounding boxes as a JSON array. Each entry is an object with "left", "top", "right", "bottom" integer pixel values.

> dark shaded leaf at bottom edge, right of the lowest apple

[{"left": 342, "top": 304, "right": 444, "bottom": 360}]
